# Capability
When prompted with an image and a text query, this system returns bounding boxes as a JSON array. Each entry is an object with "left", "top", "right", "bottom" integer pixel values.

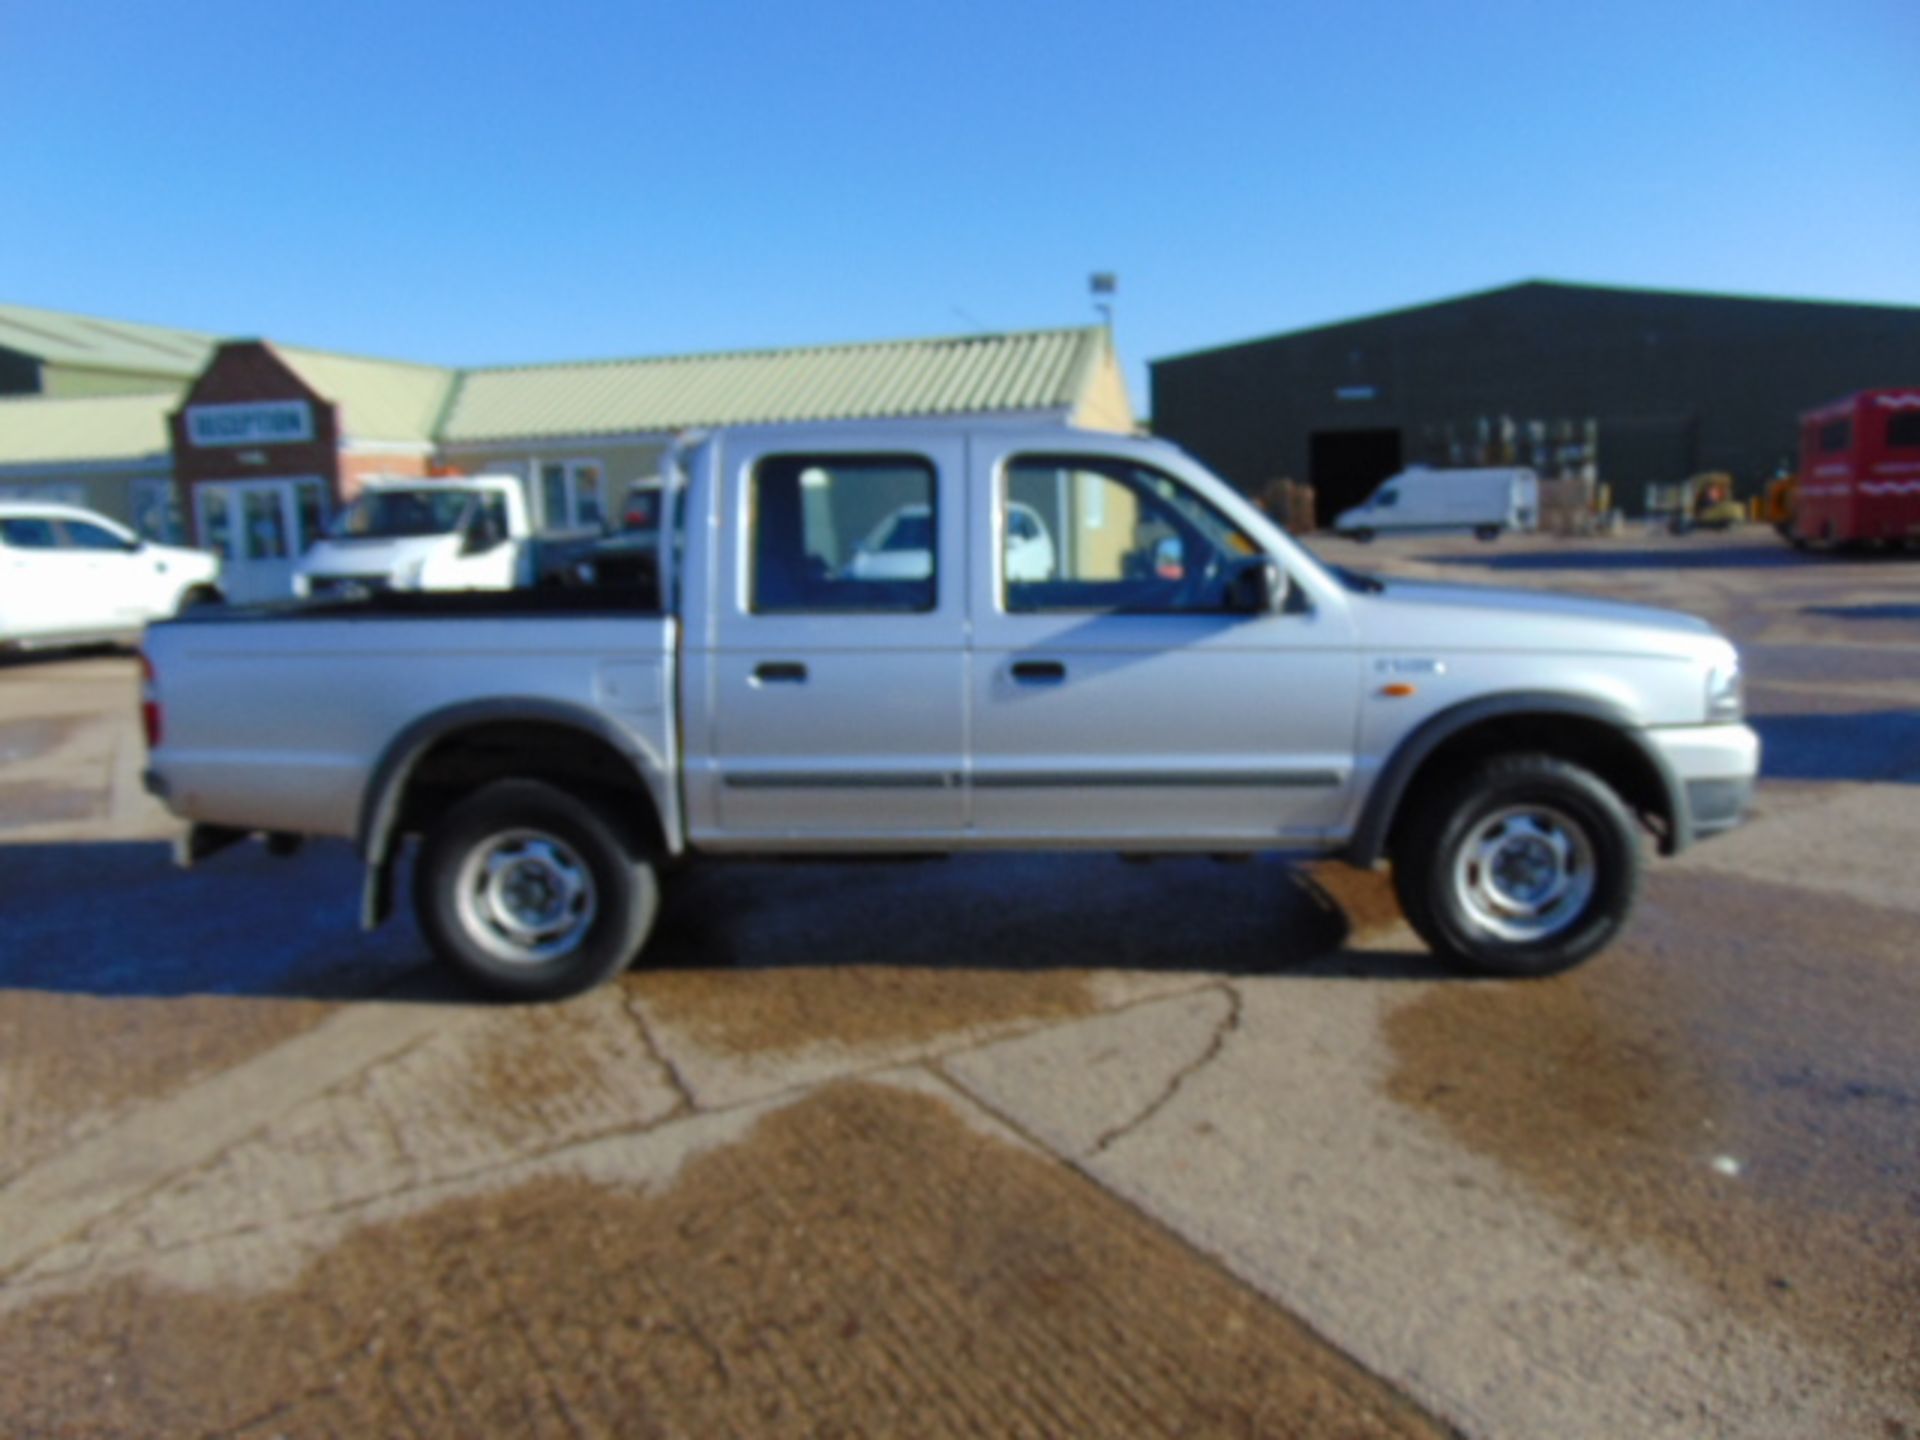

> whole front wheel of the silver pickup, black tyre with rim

[{"left": 1394, "top": 755, "right": 1640, "bottom": 975}]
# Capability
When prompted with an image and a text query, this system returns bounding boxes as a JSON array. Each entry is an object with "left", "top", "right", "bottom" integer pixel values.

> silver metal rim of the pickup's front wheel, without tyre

[{"left": 1453, "top": 804, "right": 1597, "bottom": 945}]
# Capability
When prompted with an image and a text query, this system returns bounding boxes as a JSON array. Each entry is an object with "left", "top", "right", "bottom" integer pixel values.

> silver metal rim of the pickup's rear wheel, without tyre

[{"left": 455, "top": 829, "right": 599, "bottom": 966}]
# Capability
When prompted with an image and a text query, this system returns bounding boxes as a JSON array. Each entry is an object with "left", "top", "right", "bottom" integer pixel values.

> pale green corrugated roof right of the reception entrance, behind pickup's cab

[{"left": 440, "top": 326, "right": 1108, "bottom": 445}]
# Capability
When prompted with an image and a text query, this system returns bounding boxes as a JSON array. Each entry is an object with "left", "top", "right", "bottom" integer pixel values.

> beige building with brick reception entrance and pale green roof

[{"left": 0, "top": 307, "right": 1135, "bottom": 588}]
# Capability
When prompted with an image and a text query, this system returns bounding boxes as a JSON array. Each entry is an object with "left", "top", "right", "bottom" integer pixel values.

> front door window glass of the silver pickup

[{"left": 1000, "top": 455, "right": 1256, "bottom": 614}]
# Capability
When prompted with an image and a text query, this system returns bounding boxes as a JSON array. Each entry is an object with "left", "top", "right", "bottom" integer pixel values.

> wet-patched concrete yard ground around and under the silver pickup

[{"left": 0, "top": 530, "right": 1920, "bottom": 1440}]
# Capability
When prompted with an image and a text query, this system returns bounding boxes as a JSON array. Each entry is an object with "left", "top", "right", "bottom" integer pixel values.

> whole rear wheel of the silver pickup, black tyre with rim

[{"left": 413, "top": 780, "right": 660, "bottom": 1000}]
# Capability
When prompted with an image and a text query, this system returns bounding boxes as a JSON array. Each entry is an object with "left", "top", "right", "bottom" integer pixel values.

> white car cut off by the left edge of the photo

[{"left": 0, "top": 501, "right": 221, "bottom": 649}]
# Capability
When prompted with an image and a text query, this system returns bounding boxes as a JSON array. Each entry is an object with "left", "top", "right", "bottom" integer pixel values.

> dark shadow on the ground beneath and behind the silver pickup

[{"left": 0, "top": 843, "right": 1448, "bottom": 1004}]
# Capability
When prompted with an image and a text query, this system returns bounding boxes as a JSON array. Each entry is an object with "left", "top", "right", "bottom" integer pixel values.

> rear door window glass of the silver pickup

[{"left": 749, "top": 453, "right": 941, "bottom": 614}]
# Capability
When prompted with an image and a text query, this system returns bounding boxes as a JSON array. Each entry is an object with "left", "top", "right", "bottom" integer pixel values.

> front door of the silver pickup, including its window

[{"left": 970, "top": 442, "right": 1357, "bottom": 849}]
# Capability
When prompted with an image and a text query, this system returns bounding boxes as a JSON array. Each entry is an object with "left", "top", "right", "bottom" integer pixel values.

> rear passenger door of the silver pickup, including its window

[{"left": 685, "top": 436, "right": 966, "bottom": 847}]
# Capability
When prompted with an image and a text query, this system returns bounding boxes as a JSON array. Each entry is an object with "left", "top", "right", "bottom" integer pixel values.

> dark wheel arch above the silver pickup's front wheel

[{"left": 1348, "top": 693, "right": 1692, "bottom": 866}]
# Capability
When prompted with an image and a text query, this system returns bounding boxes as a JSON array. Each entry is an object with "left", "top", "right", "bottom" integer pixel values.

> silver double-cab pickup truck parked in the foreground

[{"left": 146, "top": 422, "right": 1759, "bottom": 996}]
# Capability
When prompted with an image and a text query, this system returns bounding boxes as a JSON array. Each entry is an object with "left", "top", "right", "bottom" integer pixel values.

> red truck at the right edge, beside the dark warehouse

[{"left": 1791, "top": 388, "right": 1920, "bottom": 545}]
